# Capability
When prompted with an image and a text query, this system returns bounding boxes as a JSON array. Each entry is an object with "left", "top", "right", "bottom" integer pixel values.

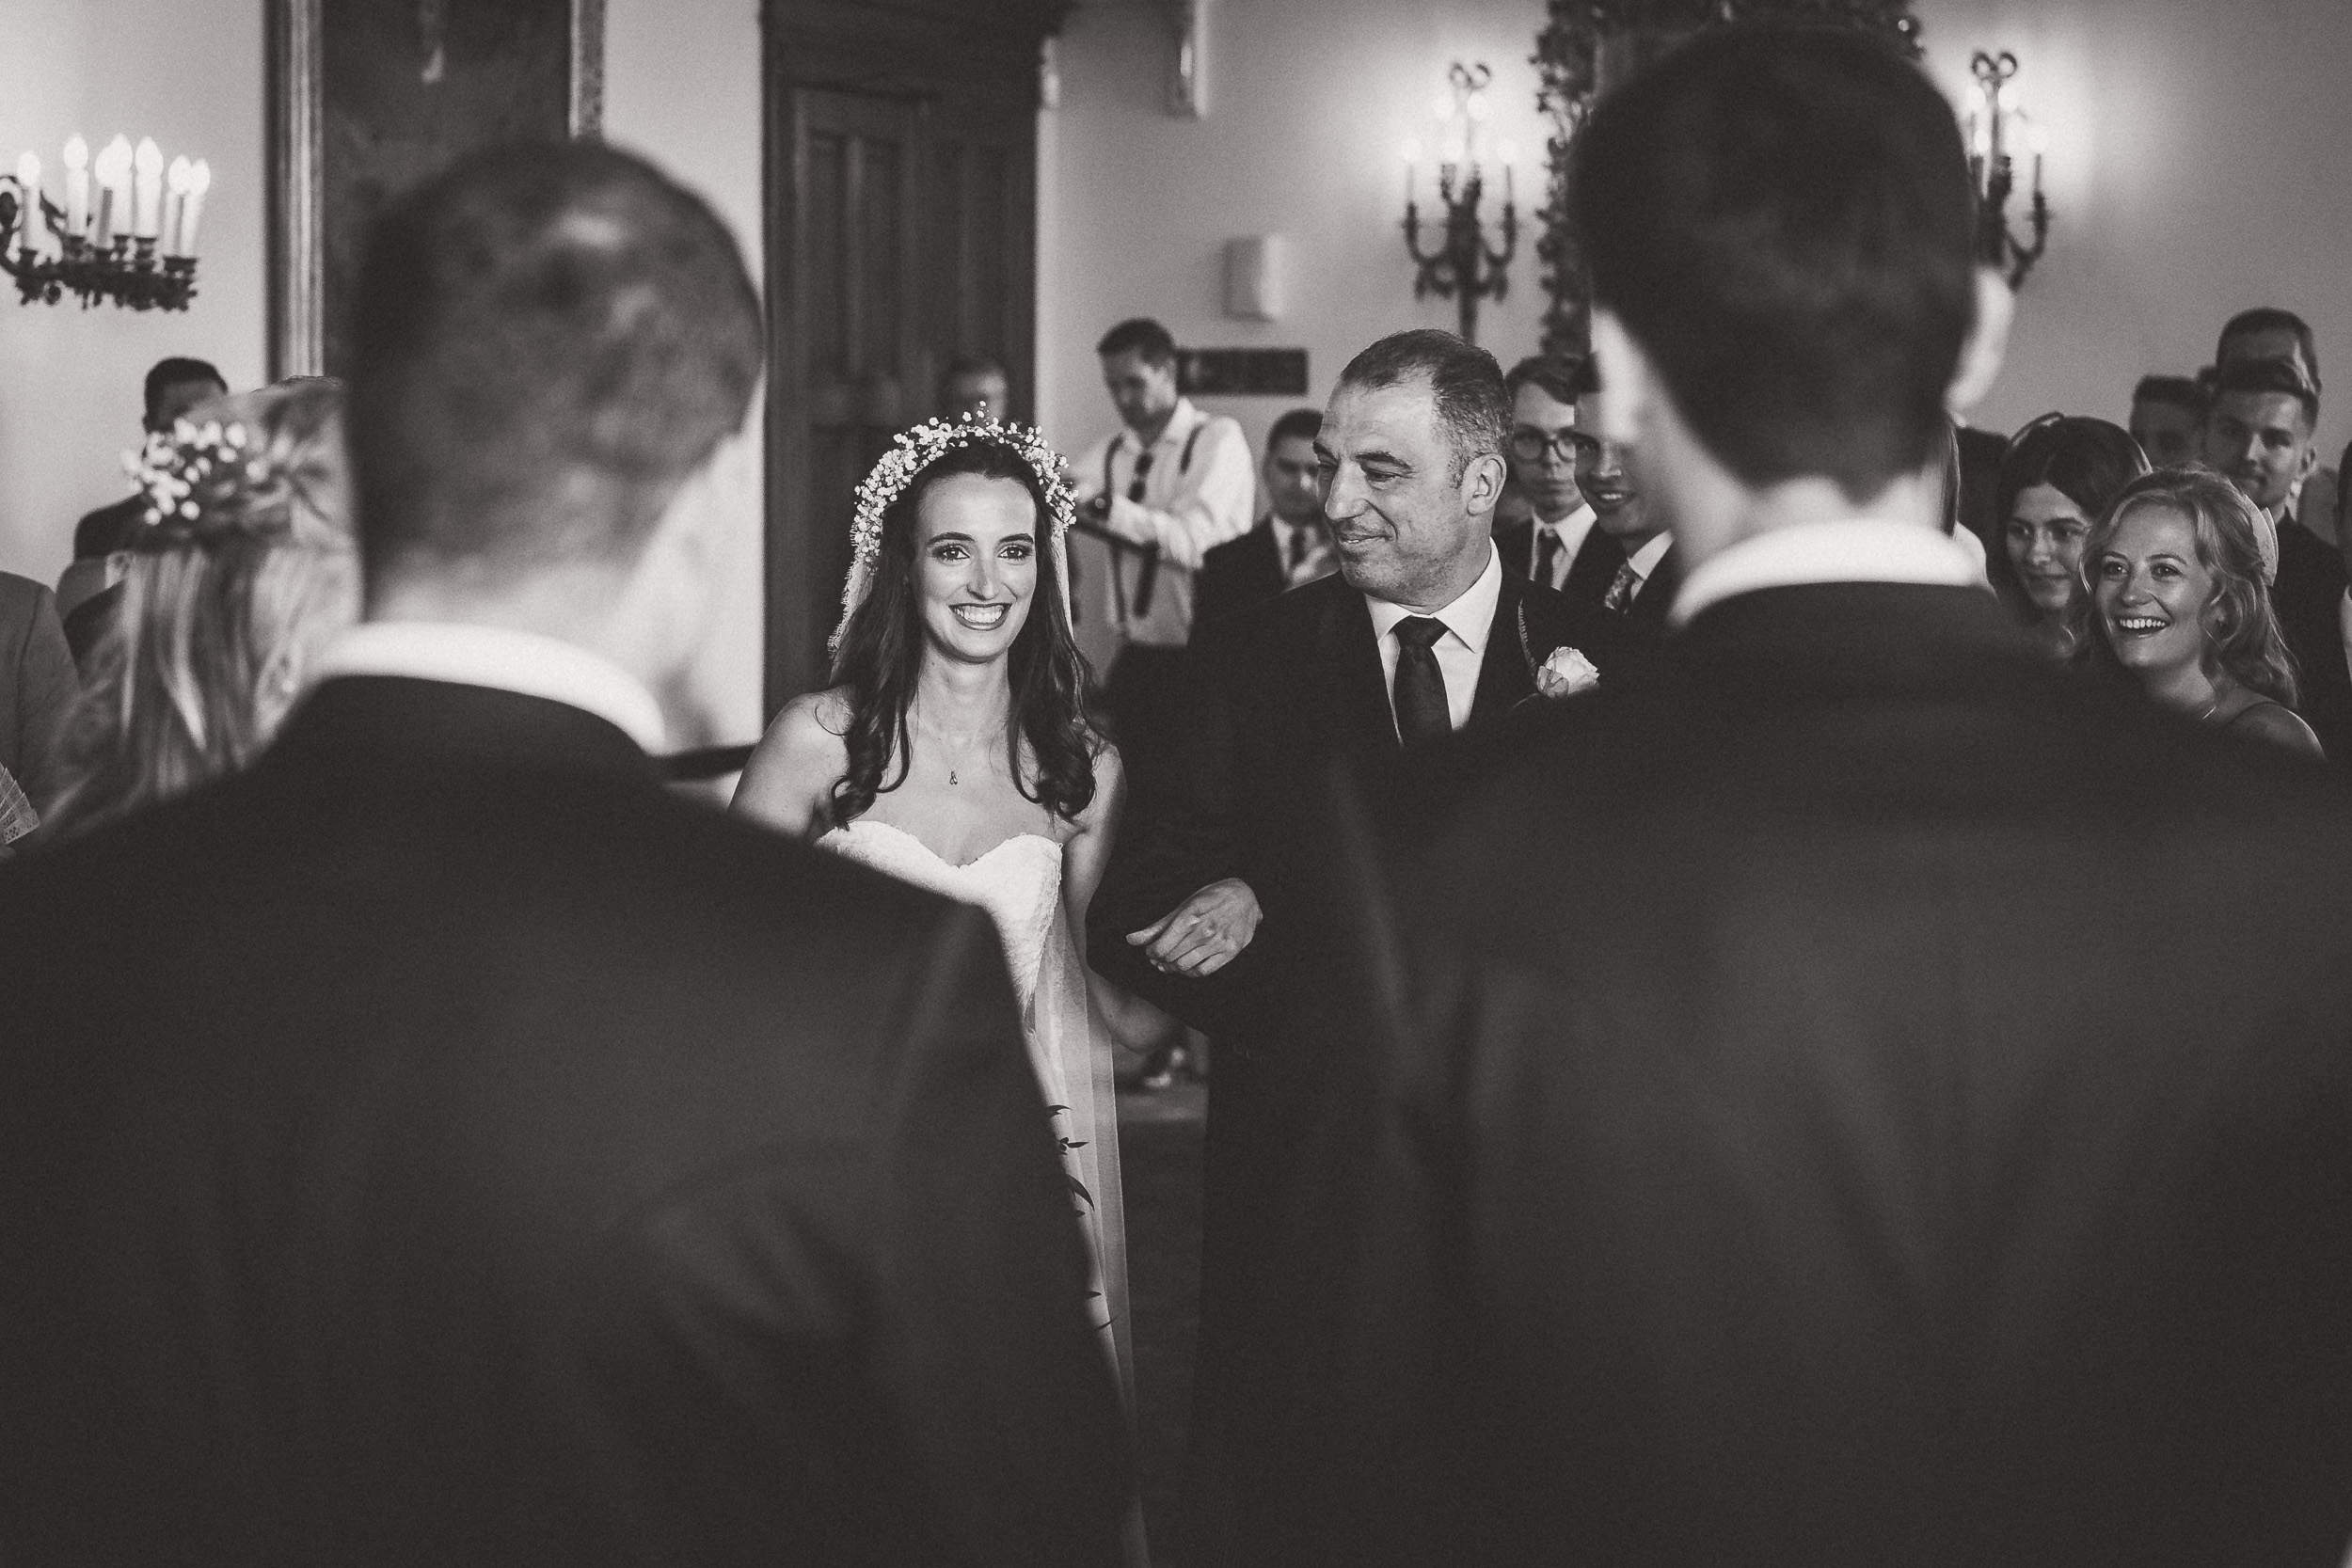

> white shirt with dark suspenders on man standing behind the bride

[{"left": 1073, "top": 397, "right": 1259, "bottom": 649}]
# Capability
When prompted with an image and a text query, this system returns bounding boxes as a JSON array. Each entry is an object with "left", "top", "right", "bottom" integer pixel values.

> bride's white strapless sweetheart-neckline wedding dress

[{"left": 817, "top": 816, "right": 1134, "bottom": 1399}]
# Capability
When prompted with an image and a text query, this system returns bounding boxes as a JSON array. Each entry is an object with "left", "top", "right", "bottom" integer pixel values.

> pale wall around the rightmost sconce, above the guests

[{"left": 1917, "top": 0, "right": 2352, "bottom": 463}]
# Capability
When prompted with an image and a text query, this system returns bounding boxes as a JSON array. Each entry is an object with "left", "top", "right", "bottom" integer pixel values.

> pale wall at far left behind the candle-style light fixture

[{"left": 0, "top": 0, "right": 268, "bottom": 583}]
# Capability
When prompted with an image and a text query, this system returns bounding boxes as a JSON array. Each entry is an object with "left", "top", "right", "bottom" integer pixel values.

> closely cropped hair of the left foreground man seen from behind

[{"left": 351, "top": 141, "right": 762, "bottom": 580}]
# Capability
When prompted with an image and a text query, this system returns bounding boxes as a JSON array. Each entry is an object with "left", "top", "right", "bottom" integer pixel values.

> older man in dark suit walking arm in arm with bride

[{"left": 1089, "top": 331, "right": 1609, "bottom": 1551}]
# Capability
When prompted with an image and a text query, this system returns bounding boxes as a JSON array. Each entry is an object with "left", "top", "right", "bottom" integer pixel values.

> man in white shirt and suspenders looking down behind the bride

[{"left": 1075, "top": 320, "right": 1256, "bottom": 797}]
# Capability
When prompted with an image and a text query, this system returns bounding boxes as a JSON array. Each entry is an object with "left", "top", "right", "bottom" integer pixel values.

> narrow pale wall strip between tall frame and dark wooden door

[{"left": 605, "top": 0, "right": 765, "bottom": 745}]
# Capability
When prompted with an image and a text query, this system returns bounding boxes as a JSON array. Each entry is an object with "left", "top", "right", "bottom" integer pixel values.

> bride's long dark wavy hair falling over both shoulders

[{"left": 833, "top": 442, "right": 1104, "bottom": 823}]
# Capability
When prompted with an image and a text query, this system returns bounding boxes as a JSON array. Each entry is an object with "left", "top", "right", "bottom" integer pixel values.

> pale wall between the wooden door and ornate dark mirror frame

[{"left": 1038, "top": 0, "right": 1543, "bottom": 472}]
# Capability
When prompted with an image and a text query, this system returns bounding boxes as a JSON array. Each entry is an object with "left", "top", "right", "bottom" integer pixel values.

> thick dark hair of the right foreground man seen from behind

[{"left": 1571, "top": 28, "right": 1976, "bottom": 503}]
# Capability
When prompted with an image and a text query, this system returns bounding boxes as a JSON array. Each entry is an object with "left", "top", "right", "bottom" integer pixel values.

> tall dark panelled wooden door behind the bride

[{"left": 762, "top": 0, "right": 1058, "bottom": 712}]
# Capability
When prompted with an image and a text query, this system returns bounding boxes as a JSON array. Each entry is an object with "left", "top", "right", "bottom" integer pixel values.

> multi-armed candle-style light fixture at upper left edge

[{"left": 0, "top": 136, "right": 212, "bottom": 310}]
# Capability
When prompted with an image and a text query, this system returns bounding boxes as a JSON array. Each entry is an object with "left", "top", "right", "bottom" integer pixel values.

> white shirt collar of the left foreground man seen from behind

[{"left": 310, "top": 621, "right": 668, "bottom": 752}]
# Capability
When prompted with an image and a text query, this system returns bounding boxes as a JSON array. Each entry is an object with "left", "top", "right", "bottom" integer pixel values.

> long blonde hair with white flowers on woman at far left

[{"left": 42, "top": 376, "right": 358, "bottom": 837}]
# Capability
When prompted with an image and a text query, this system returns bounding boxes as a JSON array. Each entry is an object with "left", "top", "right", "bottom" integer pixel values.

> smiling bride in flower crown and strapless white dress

[{"left": 734, "top": 416, "right": 1134, "bottom": 1394}]
